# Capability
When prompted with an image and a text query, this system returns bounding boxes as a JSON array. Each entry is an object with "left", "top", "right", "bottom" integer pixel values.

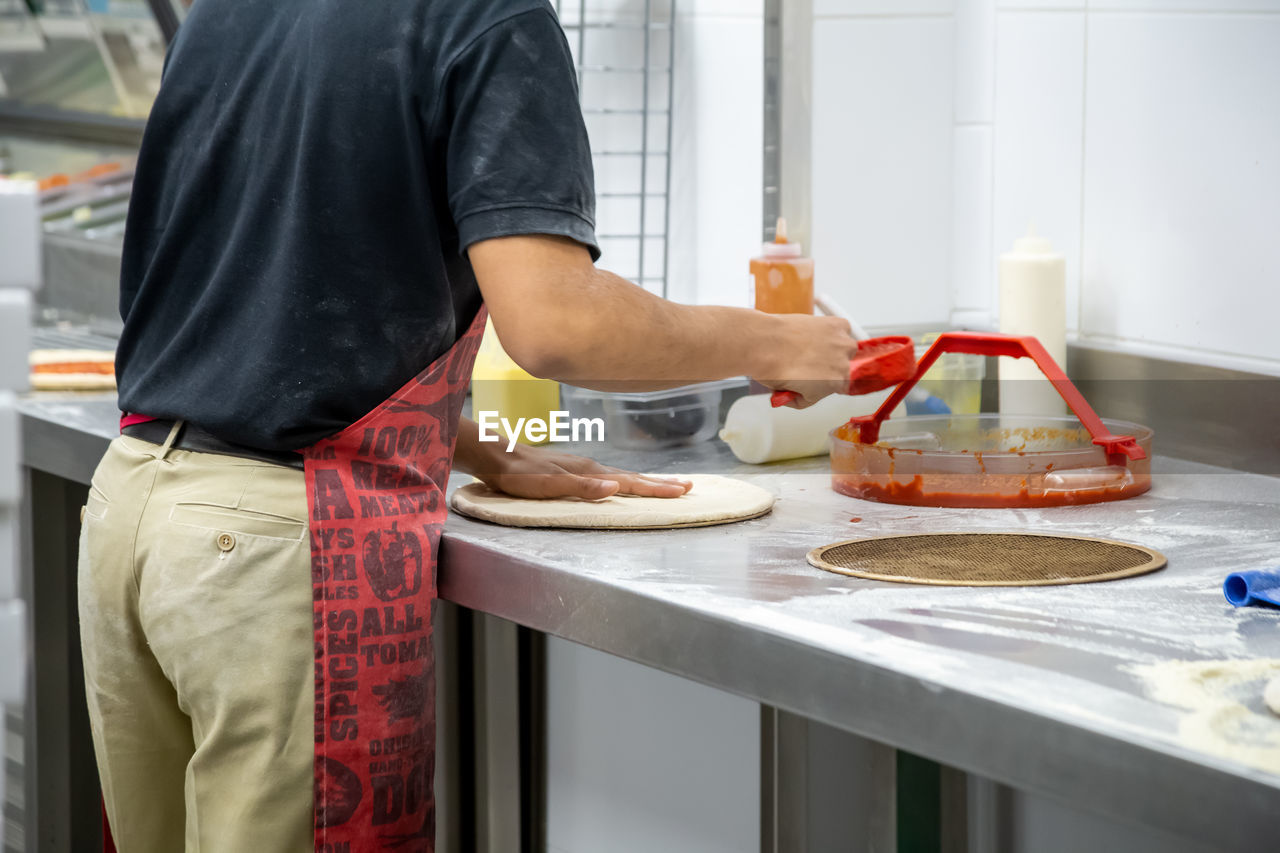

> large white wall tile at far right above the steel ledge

[{"left": 1083, "top": 14, "right": 1280, "bottom": 361}]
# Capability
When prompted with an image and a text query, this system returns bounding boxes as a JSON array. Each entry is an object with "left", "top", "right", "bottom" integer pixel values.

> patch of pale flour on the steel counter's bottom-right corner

[{"left": 1128, "top": 658, "right": 1280, "bottom": 774}]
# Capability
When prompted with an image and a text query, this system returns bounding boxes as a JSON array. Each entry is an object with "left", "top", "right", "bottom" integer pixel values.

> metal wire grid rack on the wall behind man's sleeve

[{"left": 554, "top": 0, "right": 676, "bottom": 296}]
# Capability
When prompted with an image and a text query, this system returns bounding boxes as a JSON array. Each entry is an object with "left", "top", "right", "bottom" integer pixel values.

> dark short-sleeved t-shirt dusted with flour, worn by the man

[{"left": 116, "top": 0, "right": 599, "bottom": 450}]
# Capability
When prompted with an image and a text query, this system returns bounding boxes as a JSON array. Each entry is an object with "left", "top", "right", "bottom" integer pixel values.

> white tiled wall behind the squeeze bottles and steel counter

[{"left": 650, "top": 0, "right": 1280, "bottom": 373}]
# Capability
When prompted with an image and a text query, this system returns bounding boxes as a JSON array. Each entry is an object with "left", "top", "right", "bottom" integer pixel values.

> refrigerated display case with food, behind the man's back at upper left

[{"left": 0, "top": 0, "right": 179, "bottom": 338}]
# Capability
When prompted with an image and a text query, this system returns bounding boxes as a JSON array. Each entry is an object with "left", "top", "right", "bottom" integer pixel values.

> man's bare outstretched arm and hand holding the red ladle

[{"left": 468, "top": 236, "right": 858, "bottom": 403}]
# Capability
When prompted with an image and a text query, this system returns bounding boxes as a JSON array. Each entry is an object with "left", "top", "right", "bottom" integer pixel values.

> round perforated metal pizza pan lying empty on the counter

[{"left": 808, "top": 533, "right": 1169, "bottom": 587}]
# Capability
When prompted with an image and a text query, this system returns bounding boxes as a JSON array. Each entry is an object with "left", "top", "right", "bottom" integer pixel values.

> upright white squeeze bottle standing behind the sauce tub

[{"left": 1000, "top": 225, "right": 1066, "bottom": 415}]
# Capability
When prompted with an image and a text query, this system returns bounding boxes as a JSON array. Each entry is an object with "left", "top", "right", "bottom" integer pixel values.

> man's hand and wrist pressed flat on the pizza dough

[{"left": 454, "top": 418, "right": 692, "bottom": 501}]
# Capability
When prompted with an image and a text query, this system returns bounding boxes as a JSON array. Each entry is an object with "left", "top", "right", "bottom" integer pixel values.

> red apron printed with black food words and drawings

[{"left": 305, "top": 307, "right": 485, "bottom": 853}]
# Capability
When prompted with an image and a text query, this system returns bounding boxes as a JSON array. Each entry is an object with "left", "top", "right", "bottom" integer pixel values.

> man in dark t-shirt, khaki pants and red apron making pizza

[{"left": 79, "top": 0, "right": 856, "bottom": 853}]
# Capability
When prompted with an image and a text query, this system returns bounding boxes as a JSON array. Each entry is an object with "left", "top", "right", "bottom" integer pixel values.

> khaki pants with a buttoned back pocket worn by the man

[{"left": 79, "top": 437, "right": 315, "bottom": 853}]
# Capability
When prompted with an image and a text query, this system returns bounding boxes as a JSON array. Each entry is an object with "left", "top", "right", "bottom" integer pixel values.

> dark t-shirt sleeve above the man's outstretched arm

[{"left": 442, "top": 9, "right": 600, "bottom": 260}]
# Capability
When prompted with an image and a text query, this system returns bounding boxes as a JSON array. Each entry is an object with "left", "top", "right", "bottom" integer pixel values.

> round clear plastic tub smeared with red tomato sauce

[{"left": 831, "top": 414, "right": 1152, "bottom": 507}]
